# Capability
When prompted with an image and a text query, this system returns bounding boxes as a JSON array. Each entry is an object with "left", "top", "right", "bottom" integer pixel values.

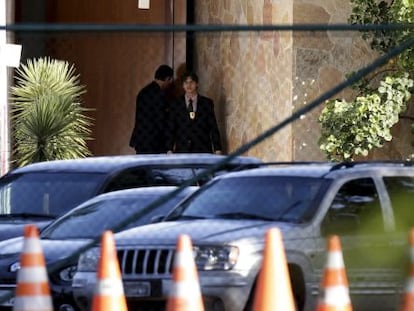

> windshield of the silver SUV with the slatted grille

[{"left": 166, "top": 176, "right": 328, "bottom": 223}]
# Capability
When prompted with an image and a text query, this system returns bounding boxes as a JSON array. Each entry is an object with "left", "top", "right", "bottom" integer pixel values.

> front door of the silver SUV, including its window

[{"left": 318, "top": 177, "right": 399, "bottom": 310}]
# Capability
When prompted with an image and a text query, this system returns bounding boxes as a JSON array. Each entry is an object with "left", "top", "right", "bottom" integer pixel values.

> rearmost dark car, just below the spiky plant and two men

[{"left": 0, "top": 154, "right": 261, "bottom": 241}]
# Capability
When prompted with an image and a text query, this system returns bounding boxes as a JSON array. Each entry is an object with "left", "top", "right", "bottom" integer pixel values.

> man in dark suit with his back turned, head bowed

[{"left": 129, "top": 65, "right": 174, "bottom": 154}]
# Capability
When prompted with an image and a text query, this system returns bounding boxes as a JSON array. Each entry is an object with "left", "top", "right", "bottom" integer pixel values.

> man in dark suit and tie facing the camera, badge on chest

[{"left": 166, "top": 72, "right": 222, "bottom": 154}]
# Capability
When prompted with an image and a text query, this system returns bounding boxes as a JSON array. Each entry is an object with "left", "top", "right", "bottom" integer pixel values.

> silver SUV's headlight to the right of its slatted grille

[{"left": 194, "top": 245, "right": 239, "bottom": 270}]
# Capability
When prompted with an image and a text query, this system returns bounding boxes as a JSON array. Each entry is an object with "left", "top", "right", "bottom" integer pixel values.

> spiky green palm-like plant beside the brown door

[{"left": 11, "top": 58, "right": 92, "bottom": 166}]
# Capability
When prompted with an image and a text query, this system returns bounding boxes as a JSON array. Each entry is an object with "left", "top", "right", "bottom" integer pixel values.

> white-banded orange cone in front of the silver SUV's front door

[{"left": 316, "top": 235, "right": 352, "bottom": 311}]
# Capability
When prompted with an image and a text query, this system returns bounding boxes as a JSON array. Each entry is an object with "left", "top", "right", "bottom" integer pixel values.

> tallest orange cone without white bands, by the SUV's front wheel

[{"left": 253, "top": 228, "right": 296, "bottom": 311}]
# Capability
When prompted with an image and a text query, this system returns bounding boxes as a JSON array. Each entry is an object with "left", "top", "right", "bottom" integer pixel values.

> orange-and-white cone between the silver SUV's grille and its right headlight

[{"left": 167, "top": 234, "right": 204, "bottom": 311}]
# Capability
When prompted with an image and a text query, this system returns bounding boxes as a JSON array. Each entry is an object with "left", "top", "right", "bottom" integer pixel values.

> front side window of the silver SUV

[{"left": 323, "top": 178, "right": 384, "bottom": 234}]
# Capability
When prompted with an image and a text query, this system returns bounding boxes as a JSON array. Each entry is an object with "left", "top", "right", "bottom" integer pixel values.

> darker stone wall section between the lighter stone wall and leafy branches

[{"left": 293, "top": 0, "right": 375, "bottom": 161}]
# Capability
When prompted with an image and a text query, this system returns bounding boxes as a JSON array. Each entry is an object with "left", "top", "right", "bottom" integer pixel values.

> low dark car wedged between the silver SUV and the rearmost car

[{"left": 0, "top": 186, "right": 198, "bottom": 311}]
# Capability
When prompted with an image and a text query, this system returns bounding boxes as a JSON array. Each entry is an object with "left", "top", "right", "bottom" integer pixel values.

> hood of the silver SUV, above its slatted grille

[{"left": 115, "top": 219, "right": 308, "bottom": 246}]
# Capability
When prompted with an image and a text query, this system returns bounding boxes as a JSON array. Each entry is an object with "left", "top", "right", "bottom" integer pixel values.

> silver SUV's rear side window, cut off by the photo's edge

[{"left": 383, "top": 176, "right": 414, "bottom": 232}]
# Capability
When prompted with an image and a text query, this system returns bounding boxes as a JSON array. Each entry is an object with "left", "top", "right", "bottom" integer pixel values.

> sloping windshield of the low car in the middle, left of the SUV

[{"left": 41, "top": 193, "right": 184, "bottom": 240}]
